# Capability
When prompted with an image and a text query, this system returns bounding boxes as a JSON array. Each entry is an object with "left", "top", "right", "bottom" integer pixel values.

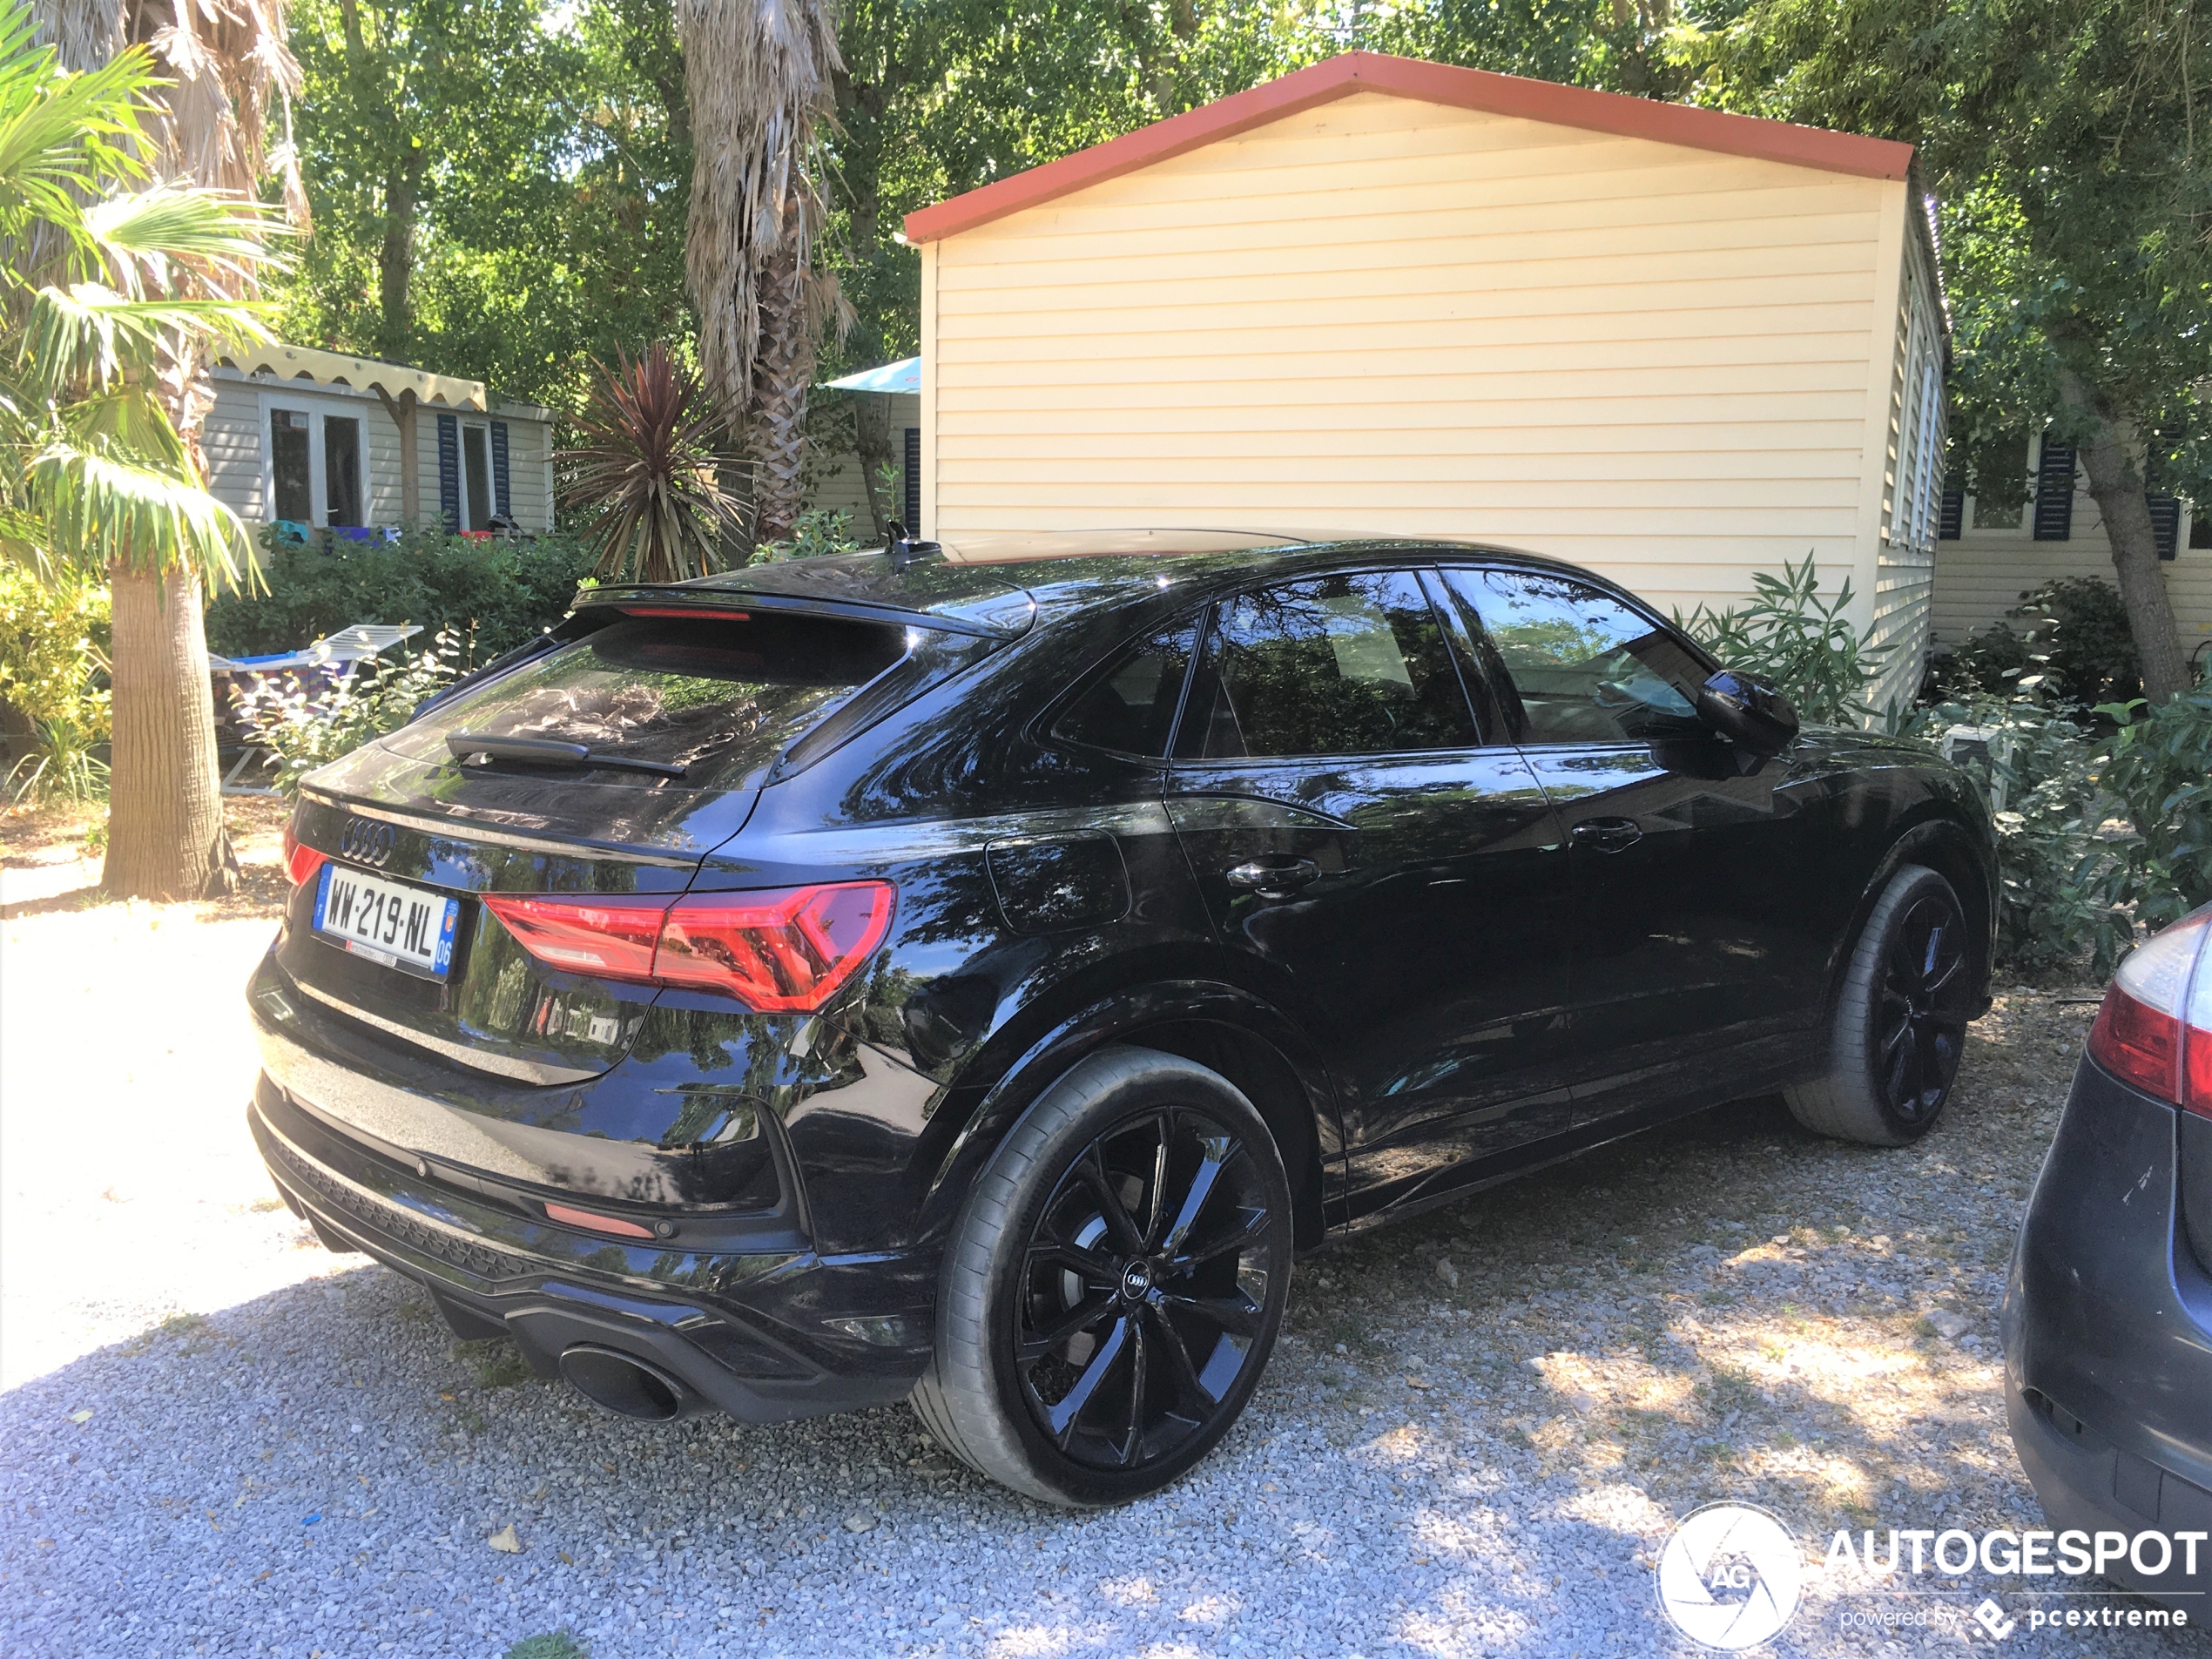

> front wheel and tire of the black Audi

[{"left": 1783, "top": 865, "right": 1979, "bottom": 1146}]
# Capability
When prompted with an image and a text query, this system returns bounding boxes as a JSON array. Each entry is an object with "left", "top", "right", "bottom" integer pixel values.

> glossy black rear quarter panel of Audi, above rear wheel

[{"left": 692, "top": 624, "right": 1247, "bottom": 1252}]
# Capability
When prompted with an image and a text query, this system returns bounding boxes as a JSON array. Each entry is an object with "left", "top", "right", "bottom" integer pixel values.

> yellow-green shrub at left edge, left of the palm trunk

[{"left": 0, "top": 564, "right": 111, "bottom": 803}]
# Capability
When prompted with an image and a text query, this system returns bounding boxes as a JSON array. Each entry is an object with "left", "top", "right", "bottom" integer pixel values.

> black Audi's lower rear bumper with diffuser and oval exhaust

[{"left": 247, "top": 1092, "right": 929, "bottom": 1422}]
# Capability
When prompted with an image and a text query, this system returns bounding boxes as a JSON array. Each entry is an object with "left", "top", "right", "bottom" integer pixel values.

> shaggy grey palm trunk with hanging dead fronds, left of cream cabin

[{"left": 677, "top": 0, "right": 849, "bottom": 553}]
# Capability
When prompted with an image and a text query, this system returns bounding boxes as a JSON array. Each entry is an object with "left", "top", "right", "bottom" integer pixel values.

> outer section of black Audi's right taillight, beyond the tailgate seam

[{"left": 652, "top": 880, "right": 892, "bottom": 1013}]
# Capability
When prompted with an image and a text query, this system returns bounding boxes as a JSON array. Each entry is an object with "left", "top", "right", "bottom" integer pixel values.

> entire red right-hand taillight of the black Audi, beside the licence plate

[{"left": 484, "top": 880, "right": 894, "bottom": 1013}]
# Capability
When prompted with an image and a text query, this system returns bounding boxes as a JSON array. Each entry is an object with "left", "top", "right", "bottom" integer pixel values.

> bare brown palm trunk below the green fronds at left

[{"left": 99, "top": 564, "right": 239, "bottom": 900}]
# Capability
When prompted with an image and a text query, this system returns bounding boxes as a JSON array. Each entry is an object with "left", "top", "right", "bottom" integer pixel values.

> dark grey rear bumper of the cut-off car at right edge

[{"left": 2004, "top": 1060, "right": 2212, "bottom": 1619}]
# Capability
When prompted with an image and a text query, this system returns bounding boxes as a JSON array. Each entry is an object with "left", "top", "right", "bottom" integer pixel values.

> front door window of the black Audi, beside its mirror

[{"left": 1445, "top": 570, "right": 1705, "bottom": 743}]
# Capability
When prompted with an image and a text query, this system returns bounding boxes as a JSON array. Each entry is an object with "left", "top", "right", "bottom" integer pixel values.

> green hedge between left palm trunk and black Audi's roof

[{"left": 208, "top": 531, "right": 590, "bottom": 671}]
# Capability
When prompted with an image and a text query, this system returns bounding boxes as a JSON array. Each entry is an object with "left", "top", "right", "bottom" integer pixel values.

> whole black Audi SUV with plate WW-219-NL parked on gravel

[{"left": 250, "top": 533, "right": 1993, "bottom": 1504}]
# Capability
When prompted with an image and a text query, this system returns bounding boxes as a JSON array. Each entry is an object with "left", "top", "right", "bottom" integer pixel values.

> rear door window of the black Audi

[{"left": 1177, "top": 570, "right": 1478, "bottom": 759}]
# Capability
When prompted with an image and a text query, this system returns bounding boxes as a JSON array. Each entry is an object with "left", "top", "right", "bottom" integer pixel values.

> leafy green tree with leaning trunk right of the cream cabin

[{"left": 1679, "top": 0, "right": 2212, "bottom": 701}]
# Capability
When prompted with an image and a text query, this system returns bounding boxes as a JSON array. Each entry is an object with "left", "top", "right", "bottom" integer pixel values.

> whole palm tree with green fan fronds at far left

[{"left": 0, "top": 0, "right": 289, "bottom": 898}]
